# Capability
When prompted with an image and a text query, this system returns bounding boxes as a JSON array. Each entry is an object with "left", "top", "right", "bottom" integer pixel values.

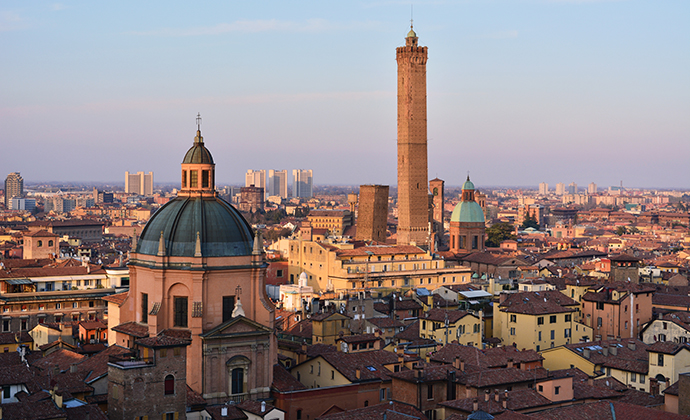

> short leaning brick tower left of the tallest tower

[{"left": 355, "top": 185, "right": 388, "bottom": 243}]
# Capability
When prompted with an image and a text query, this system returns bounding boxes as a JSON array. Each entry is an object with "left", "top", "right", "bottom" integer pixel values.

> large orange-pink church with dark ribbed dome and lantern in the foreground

[{"left": 109, "top": 119, "right": 277, "bottom": 403}]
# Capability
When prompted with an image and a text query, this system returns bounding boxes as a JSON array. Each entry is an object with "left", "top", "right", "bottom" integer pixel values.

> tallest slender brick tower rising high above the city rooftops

[{"left": 396, "top": 26, "right": 429, "bottom": 246}]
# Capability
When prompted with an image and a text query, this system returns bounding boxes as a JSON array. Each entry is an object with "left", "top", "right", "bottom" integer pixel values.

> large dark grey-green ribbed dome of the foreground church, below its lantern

[{"left": 137, "top": 196, "right": 253, "bottom": 257}]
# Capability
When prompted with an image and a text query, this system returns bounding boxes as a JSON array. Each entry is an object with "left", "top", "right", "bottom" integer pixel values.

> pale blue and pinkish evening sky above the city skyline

[{"left": 0, "top": 0, "right": 690, "bottom": 189}]
